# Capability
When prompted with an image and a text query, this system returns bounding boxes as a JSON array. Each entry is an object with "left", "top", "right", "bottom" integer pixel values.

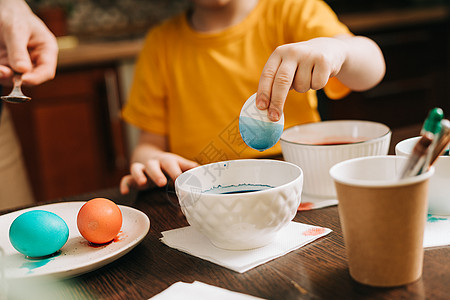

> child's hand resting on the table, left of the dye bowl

[{"left": 120, "top": 152, "right": 198, "bottom": 194}]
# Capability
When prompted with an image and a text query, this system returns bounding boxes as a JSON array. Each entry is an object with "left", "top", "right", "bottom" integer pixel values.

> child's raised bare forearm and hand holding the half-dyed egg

[{"left": 256, "top": 35, "right": 386, "bottom": 121}]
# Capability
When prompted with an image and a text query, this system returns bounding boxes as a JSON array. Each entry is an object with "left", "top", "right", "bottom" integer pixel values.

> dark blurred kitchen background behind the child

[{"left": 7, "top": 0, "right": 450, "bottom": 201}]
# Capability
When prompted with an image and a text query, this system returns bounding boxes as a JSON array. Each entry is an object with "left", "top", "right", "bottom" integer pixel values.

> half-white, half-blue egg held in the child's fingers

[{"left": 239, "top": 94, "right": 284, "bottom": 151}]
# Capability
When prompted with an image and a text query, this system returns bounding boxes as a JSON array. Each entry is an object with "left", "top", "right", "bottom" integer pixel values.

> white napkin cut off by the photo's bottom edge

[{"left": 150, "top": 281, "right": 262, "bottom": 300}]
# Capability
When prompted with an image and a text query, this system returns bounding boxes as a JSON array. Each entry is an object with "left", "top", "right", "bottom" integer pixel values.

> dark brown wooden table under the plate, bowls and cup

[{"left": 0, "top": 189, "right": 450, "bottom": 300}]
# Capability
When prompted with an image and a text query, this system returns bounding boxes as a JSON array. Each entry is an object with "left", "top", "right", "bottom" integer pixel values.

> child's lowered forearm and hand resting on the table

[{"left": 120, "top": 131, "right": 198, "bottom": 194}]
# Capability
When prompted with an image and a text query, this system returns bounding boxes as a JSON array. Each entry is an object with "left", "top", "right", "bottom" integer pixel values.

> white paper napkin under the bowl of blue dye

[{"left": 161, "top": 222, "right": 331, "bottom": 273}]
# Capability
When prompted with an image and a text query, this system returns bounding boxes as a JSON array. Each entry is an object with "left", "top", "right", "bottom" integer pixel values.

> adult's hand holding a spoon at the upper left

[{"left": 0, "top": 0, "right": 58, "bottom": 85}]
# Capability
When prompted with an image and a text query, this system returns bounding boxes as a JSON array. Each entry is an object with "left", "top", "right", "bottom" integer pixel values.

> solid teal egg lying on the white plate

[{"left": 9, "top": 210, "right": 69, "bottom": 257}]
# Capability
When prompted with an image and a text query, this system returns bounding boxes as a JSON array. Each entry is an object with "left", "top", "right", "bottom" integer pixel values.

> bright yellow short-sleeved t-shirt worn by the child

[{"left": 122, "top": 0, "right": 350, "bottom": 163}]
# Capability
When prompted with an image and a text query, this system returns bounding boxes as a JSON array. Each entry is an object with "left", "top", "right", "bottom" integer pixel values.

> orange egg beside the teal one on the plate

[{"left": 77, "top": 198, "right": 122, "bottom": 244}]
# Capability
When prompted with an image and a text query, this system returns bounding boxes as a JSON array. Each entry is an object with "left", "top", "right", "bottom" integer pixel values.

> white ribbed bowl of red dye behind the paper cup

[{"left": 280, "top": 120, "right": 391, "bottom": 199}]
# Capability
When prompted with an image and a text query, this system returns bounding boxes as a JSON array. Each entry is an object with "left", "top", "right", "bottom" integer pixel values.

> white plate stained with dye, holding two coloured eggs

[{"left": 0, "top": 202, "right": 150, "bottom": 279}]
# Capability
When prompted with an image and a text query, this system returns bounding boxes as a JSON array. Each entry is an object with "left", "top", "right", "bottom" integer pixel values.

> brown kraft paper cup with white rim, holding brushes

[{"left": 330, "top": 156, "right": 434, "bottom": 287}]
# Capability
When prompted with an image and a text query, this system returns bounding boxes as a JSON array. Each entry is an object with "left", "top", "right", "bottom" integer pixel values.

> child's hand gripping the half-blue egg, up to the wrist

[{"left": 256, "top": 38, "right": 348, "bottom": 122}]
